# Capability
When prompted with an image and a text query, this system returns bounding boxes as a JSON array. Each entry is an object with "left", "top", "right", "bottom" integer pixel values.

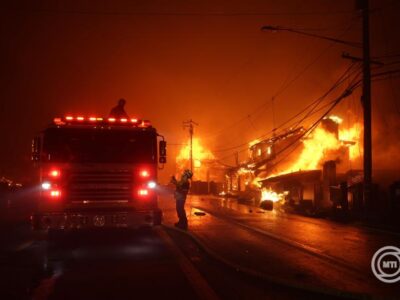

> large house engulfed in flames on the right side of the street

[{"left": 227, "top": 116, "right": 362, "bottom": 212}]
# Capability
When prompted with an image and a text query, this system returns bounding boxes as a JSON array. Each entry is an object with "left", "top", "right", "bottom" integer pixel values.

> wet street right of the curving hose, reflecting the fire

[{"left": 160, "top": 196, "right": 400, "bottom": 298}]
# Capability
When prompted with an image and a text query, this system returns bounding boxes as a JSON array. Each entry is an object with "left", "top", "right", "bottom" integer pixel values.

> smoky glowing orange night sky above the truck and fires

[{"left": 0, "top": 0, "right": 400, "bottom": 182}]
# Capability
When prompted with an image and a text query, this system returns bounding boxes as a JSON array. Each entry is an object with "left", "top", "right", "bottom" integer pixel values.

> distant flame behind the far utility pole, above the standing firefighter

[{"left": 176, "top": 138, "right": 214, "bottom": 181}]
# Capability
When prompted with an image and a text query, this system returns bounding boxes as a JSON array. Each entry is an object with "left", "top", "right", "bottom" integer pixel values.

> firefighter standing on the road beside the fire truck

[{"left": 171, "top": 170, "right": 193, "bottom": 230}]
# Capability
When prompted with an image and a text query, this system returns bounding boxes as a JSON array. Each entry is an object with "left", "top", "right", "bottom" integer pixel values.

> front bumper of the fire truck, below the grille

[{"left": 31, "top": 210, "right": 162, "bottom": 230}]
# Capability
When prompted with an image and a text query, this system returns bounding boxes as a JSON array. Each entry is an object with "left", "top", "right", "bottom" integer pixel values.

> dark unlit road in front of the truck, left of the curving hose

[{"left": 0, "top": 225, "right": 334, "bottom": 299}]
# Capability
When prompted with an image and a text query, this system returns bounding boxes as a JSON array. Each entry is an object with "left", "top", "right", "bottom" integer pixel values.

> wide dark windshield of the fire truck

[{"left": 42, "top": 128, "right": 157, "bottom": 163}]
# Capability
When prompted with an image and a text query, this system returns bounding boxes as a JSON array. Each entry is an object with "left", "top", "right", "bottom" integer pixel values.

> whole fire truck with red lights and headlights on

[{"left": 31, "top": 116, "right": 166, "bottom": 232}]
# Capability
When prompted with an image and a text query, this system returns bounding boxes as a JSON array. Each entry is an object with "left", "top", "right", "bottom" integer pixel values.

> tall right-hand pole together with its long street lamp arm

[{"left": 261, "top": 0, "right": 372, "bottom": 210}]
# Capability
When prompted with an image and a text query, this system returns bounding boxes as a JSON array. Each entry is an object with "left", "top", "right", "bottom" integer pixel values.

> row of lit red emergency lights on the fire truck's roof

[{"left": 53, "top": 115, "right": 151, "bottom": 127}]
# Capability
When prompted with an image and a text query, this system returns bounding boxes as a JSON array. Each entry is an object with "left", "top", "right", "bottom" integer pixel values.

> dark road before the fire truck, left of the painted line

[{"left": 0, "top": 230, "right": 196, "bottom": 299}]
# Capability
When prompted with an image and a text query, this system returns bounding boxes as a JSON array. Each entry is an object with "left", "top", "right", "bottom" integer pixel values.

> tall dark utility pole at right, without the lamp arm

[{"left": 358, "top": 0, "right": 372, "bottom": 207}]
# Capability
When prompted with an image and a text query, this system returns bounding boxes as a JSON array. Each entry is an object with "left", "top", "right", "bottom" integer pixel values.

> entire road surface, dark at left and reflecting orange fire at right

[{"left": 0, "top": 195, "right": 400, "bottom": 299}]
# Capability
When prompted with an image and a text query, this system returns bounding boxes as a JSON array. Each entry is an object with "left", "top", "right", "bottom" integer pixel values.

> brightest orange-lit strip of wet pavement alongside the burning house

[{"left": 190, "top": 197, "right": 400, "bottom": 272}]
